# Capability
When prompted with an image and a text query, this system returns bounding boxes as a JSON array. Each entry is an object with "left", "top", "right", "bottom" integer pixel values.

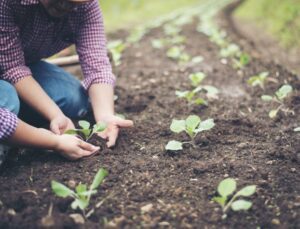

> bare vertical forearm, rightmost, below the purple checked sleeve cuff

[{"left": 89, "top": 84, "right": 114, "bottom": 122}]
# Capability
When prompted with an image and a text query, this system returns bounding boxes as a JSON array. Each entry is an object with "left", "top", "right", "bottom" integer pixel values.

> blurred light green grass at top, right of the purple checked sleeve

[{"left": 99, "top": 0, "right": 207, "bottom": 32}]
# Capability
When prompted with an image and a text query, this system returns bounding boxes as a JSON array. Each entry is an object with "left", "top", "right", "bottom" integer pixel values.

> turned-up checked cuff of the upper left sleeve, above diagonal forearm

[{"left": 2, "top": 66, "right": 32, "bottom": 84}]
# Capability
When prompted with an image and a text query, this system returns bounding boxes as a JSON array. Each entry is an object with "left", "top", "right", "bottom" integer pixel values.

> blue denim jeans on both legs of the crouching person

[{"left": 0, "top": 61, "right": 90, "bottom": 125}]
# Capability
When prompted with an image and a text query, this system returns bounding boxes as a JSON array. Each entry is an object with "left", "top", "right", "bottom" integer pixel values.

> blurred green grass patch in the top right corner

[{"left": 235, "top": 0, "right": 300, "bottom": 48}]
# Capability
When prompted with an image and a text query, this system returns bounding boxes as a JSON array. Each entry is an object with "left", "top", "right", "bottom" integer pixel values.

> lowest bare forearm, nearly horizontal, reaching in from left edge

[{"left": 7, "top": 120, "right": 58, "bottom": 149}]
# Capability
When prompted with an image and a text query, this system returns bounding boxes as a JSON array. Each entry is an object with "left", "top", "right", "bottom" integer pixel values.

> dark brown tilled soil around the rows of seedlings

[{"left": 0, "top": 2, "right": 300, "bottom": 228}]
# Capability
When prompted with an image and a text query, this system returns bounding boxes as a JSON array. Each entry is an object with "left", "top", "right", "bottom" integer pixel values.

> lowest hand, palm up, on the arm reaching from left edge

[{"left": 55, "top": 134, "right": 100, "bottom": 160}]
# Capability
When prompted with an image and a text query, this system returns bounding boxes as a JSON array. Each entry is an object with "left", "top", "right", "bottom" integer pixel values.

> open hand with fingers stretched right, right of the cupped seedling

[{"left": 98, "top": 115, "right": 133, "bottom": 147}]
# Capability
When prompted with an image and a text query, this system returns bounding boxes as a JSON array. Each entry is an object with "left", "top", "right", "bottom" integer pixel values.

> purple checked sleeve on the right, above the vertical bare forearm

[{"left": 75, "top": 0, "right": 115, "bottom": 89}]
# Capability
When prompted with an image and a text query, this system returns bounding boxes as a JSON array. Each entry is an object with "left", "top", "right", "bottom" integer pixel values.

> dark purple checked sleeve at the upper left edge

[{"left": 0, "top": 0, "right": 32, "bottom": 84}]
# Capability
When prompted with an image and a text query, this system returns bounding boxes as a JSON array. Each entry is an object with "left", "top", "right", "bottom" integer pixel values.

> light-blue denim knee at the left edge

[{"left": 0, "top": 80, "right": 20, "bottom": 115}]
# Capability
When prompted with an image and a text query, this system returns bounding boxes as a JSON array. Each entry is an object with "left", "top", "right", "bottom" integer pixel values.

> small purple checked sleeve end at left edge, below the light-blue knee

[{"left": 0, "top": 108, "right": 18, "bottom": 140}]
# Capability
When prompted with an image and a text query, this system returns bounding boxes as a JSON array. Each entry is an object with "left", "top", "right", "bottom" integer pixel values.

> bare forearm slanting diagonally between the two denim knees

[{"left": 15, "top": 76, "right": 62, "bottom": 121}]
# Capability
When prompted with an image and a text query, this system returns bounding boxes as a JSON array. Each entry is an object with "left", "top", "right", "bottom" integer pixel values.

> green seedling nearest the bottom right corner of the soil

[{"left": 213, "top": 178, "right": 256, "bottom": 219}]
